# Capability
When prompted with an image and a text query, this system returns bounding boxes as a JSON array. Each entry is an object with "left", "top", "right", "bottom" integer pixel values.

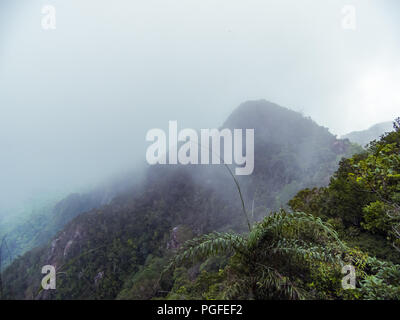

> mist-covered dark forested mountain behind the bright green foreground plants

[{"left": 3, "top": 100, "right": 359, "bottom": 299}]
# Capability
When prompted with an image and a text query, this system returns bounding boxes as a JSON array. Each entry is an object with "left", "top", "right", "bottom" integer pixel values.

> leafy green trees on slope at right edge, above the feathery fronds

[{"left": 289, "top": 119, "right": 400, "bottom": 263}]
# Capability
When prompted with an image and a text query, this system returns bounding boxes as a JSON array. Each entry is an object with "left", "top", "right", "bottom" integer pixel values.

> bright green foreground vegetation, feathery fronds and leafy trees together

[{"left": 164, "top": 119, "right": 400, "bottom": 300}]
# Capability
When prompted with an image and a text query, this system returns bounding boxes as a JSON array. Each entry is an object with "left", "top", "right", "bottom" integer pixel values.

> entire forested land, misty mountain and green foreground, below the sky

[{"left": 0, "top": 101, "right": 400, "bottom": 299}]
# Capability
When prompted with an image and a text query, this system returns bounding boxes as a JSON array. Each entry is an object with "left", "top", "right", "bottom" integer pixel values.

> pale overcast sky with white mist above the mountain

[{"left": 0, "top": 0, "right": 400, "bottom": 214}]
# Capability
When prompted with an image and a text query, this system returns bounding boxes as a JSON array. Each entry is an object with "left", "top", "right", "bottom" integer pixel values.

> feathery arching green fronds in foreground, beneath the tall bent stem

[{"left": 167, "top": 211, "right": 345, "bottom": 299}]
